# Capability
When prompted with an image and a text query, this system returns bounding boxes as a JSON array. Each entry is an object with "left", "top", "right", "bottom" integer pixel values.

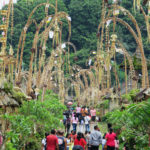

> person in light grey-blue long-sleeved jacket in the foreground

[{"left": 89, "top": 125, "right": 102, "bottom": 150}]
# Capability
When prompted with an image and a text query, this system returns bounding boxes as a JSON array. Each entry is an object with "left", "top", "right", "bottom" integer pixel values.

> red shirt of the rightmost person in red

[{"left": 105, "top": 132, "right": 116, "bottom": 147}]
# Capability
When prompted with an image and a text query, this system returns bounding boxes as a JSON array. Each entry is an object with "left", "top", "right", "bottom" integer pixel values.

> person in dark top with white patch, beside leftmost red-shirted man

[{"left": 57, "top": 130, "right": 67, "bottom": 150}]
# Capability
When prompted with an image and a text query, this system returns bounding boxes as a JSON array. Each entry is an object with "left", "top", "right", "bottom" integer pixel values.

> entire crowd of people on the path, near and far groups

[{"left": 42, "top": 105, "right": 119, "bottom": 150}]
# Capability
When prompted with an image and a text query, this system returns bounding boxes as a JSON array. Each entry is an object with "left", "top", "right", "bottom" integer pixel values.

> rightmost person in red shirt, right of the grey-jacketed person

[{"left": 105, "top": 128, "right": 116, "bottom": 150}]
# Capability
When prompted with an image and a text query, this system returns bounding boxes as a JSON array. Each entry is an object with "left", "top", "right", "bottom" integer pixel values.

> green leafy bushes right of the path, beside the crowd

[{"left": 106, "top": 100, "right": 150, "bottom": 150}]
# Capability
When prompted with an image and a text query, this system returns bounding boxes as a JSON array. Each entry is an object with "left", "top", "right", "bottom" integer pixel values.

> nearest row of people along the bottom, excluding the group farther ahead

[{"left": 42, "top": 125, "right": 119, "bottom": 150}]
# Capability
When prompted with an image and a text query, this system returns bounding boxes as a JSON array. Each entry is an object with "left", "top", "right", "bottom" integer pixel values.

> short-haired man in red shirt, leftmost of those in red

[{"left": 46, "top": 130, "right": 59, "bottom": 150}]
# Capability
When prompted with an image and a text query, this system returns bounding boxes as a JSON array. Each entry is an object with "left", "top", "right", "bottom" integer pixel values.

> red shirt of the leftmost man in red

[{"left": 46, "top": 135, "right": 58, "bottom": 150}]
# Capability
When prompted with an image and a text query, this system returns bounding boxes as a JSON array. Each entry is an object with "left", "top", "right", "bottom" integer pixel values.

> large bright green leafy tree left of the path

[{"left": 5, "top": 90, "right": 65, "bottom": 150}]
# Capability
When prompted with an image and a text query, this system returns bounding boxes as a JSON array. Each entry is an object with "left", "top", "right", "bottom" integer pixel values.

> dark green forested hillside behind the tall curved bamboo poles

[{"left": 5, "top": 0, "right": 150, "bottom": 70}]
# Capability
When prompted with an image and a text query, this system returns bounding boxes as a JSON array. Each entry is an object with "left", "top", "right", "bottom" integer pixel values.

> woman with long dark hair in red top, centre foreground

[{"left": 74, "top": 132, "right": 86, "bottom": 150}]
